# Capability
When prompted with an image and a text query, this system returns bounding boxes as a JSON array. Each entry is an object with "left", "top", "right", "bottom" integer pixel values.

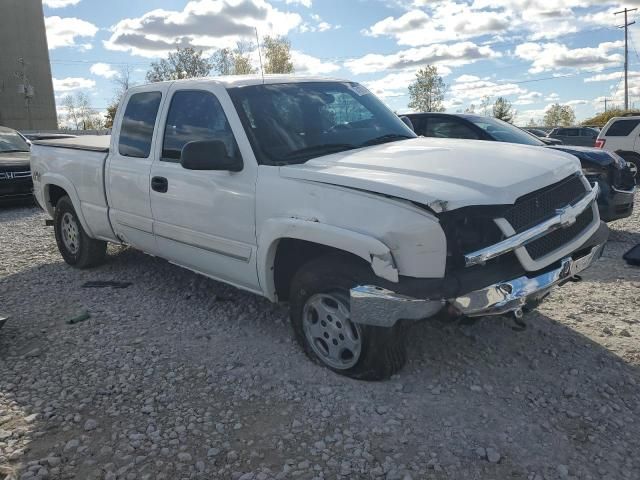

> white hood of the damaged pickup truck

[{"left": 280, "top": 138, "right": 580, "bottom": 213}]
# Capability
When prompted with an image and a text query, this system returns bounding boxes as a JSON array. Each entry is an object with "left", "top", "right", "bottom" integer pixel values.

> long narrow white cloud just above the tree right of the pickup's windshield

[{"left": 345, "top": 42, "right": 501, "bottom": 74}]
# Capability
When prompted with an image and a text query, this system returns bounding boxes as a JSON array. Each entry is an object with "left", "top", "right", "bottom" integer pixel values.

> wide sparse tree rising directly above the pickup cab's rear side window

[{"left": 147, "top": 47, "right": 213, "bottom": 82}]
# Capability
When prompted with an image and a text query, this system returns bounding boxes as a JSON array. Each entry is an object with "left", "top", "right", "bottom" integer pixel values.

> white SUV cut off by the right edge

[{"left": 596, "top": 116, "right": 640, "bottom": 182}]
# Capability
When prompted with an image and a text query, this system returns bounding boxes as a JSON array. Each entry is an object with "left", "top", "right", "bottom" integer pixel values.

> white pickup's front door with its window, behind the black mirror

[{"left": 151, "top": 82, "right": 259, "bottom": 291}]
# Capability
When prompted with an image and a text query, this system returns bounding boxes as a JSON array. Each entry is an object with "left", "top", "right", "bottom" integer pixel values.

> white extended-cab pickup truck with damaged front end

[{"left": 32, "top": 76, "right": 608, "bottom": 380}]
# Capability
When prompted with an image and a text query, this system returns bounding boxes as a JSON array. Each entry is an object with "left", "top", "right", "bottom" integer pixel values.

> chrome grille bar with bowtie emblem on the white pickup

[{"left": 464, "top": 185, "right": 600, "bottom": 267}]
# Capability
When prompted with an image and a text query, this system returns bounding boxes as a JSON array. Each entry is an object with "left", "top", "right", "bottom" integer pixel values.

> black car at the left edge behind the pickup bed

[{"left": 0, "top": 127, "right": 33, "bottom": 204}]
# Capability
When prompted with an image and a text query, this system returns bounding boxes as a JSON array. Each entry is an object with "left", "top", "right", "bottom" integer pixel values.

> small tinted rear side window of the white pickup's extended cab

[{"left": 118, "top": 92, "right": 162, "bottom": 158}]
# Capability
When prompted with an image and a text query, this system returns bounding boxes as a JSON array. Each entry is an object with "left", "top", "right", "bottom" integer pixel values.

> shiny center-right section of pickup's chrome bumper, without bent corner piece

[{"left": 450, "top": 244, "right": 604, "bottom": 317}]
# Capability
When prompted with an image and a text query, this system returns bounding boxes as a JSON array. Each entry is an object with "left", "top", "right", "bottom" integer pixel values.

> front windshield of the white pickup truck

[{"left": 229, "top": 82, "right": 416, "bottom": 165}]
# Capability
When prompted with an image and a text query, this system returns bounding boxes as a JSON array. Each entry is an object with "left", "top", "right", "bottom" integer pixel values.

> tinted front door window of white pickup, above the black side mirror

[{"left": 161, "top": 90, "right": 239, "bottom": 163}]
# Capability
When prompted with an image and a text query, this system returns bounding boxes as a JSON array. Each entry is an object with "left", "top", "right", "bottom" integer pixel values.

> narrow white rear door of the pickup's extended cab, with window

[{"left": 105, "top": 85, "right": 168, "bottom": 253}]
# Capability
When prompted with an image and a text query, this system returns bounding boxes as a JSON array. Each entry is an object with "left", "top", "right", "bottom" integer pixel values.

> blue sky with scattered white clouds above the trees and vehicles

[{"left": 44, "top": 0, "right": 640, "bottom": 124}]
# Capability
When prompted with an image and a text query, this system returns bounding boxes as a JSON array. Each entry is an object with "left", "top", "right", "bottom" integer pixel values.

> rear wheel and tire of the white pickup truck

[{"left": 53, "top": 196, "right": 107, "bottom": 269}]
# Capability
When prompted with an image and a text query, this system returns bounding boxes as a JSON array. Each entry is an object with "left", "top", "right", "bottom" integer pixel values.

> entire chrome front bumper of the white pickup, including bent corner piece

[{"left": 351, "top": 244, "right": 604, "bottom": 327}]
